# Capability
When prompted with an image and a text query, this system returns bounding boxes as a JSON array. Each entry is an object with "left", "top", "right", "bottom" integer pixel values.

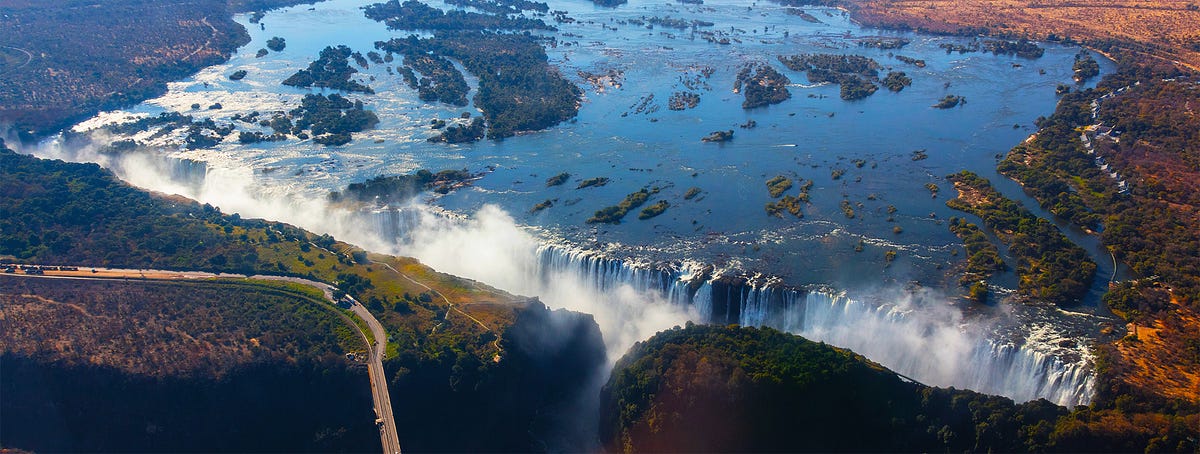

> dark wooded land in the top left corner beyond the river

[{"left": 0, "top": 0, "right": 301, "bottom": 139}]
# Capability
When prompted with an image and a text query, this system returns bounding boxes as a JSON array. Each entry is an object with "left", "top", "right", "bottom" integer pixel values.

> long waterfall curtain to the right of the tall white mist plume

[{"left": 520, "top": 245, "right": 1096, "bottom": 407}]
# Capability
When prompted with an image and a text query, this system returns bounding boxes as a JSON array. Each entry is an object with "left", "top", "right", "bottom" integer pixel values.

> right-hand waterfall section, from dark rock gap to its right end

[{"left": 739, "top": 287, "right": 1096, "bottom": 406}]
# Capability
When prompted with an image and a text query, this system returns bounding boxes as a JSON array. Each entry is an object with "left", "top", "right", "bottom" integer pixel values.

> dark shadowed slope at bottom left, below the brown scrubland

[{"left": 0, "top": 354, "right": 379, "bottom": 452}]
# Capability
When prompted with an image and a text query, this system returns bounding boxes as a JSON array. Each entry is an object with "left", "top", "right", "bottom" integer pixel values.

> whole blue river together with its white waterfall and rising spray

[{"left": 35, "top": 0, "right": 1111, "bottom": 405}]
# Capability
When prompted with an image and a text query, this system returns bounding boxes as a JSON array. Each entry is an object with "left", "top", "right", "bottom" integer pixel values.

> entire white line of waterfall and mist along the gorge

[{"left": 24, "top": 136, "right": 1096, "bottom": 406}]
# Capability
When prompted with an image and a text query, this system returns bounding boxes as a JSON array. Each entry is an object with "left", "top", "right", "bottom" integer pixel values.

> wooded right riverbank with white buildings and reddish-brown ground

[{"left": 1000, "top": 58, "right": 1200, "bottom": 410}]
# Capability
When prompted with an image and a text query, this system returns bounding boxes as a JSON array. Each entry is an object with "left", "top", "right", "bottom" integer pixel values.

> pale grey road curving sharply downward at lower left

[{"left": 5, "top": 267, "right": 403, "bottom": 454}]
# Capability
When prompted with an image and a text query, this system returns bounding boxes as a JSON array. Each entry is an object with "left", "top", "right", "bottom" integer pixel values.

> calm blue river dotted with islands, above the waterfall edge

[{"left": 70, "top": 0, "right": 1112, "bottom": 297}]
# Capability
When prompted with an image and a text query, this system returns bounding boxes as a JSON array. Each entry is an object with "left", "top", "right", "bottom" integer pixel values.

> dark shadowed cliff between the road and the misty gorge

[{"left": 385, "top": 303, "right": 606, "bottom": 452}]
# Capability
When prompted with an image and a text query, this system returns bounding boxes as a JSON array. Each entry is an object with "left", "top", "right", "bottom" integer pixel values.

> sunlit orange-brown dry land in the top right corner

[{"left": 844, "top": 0, "right": 1200, "bottom": 70}]
